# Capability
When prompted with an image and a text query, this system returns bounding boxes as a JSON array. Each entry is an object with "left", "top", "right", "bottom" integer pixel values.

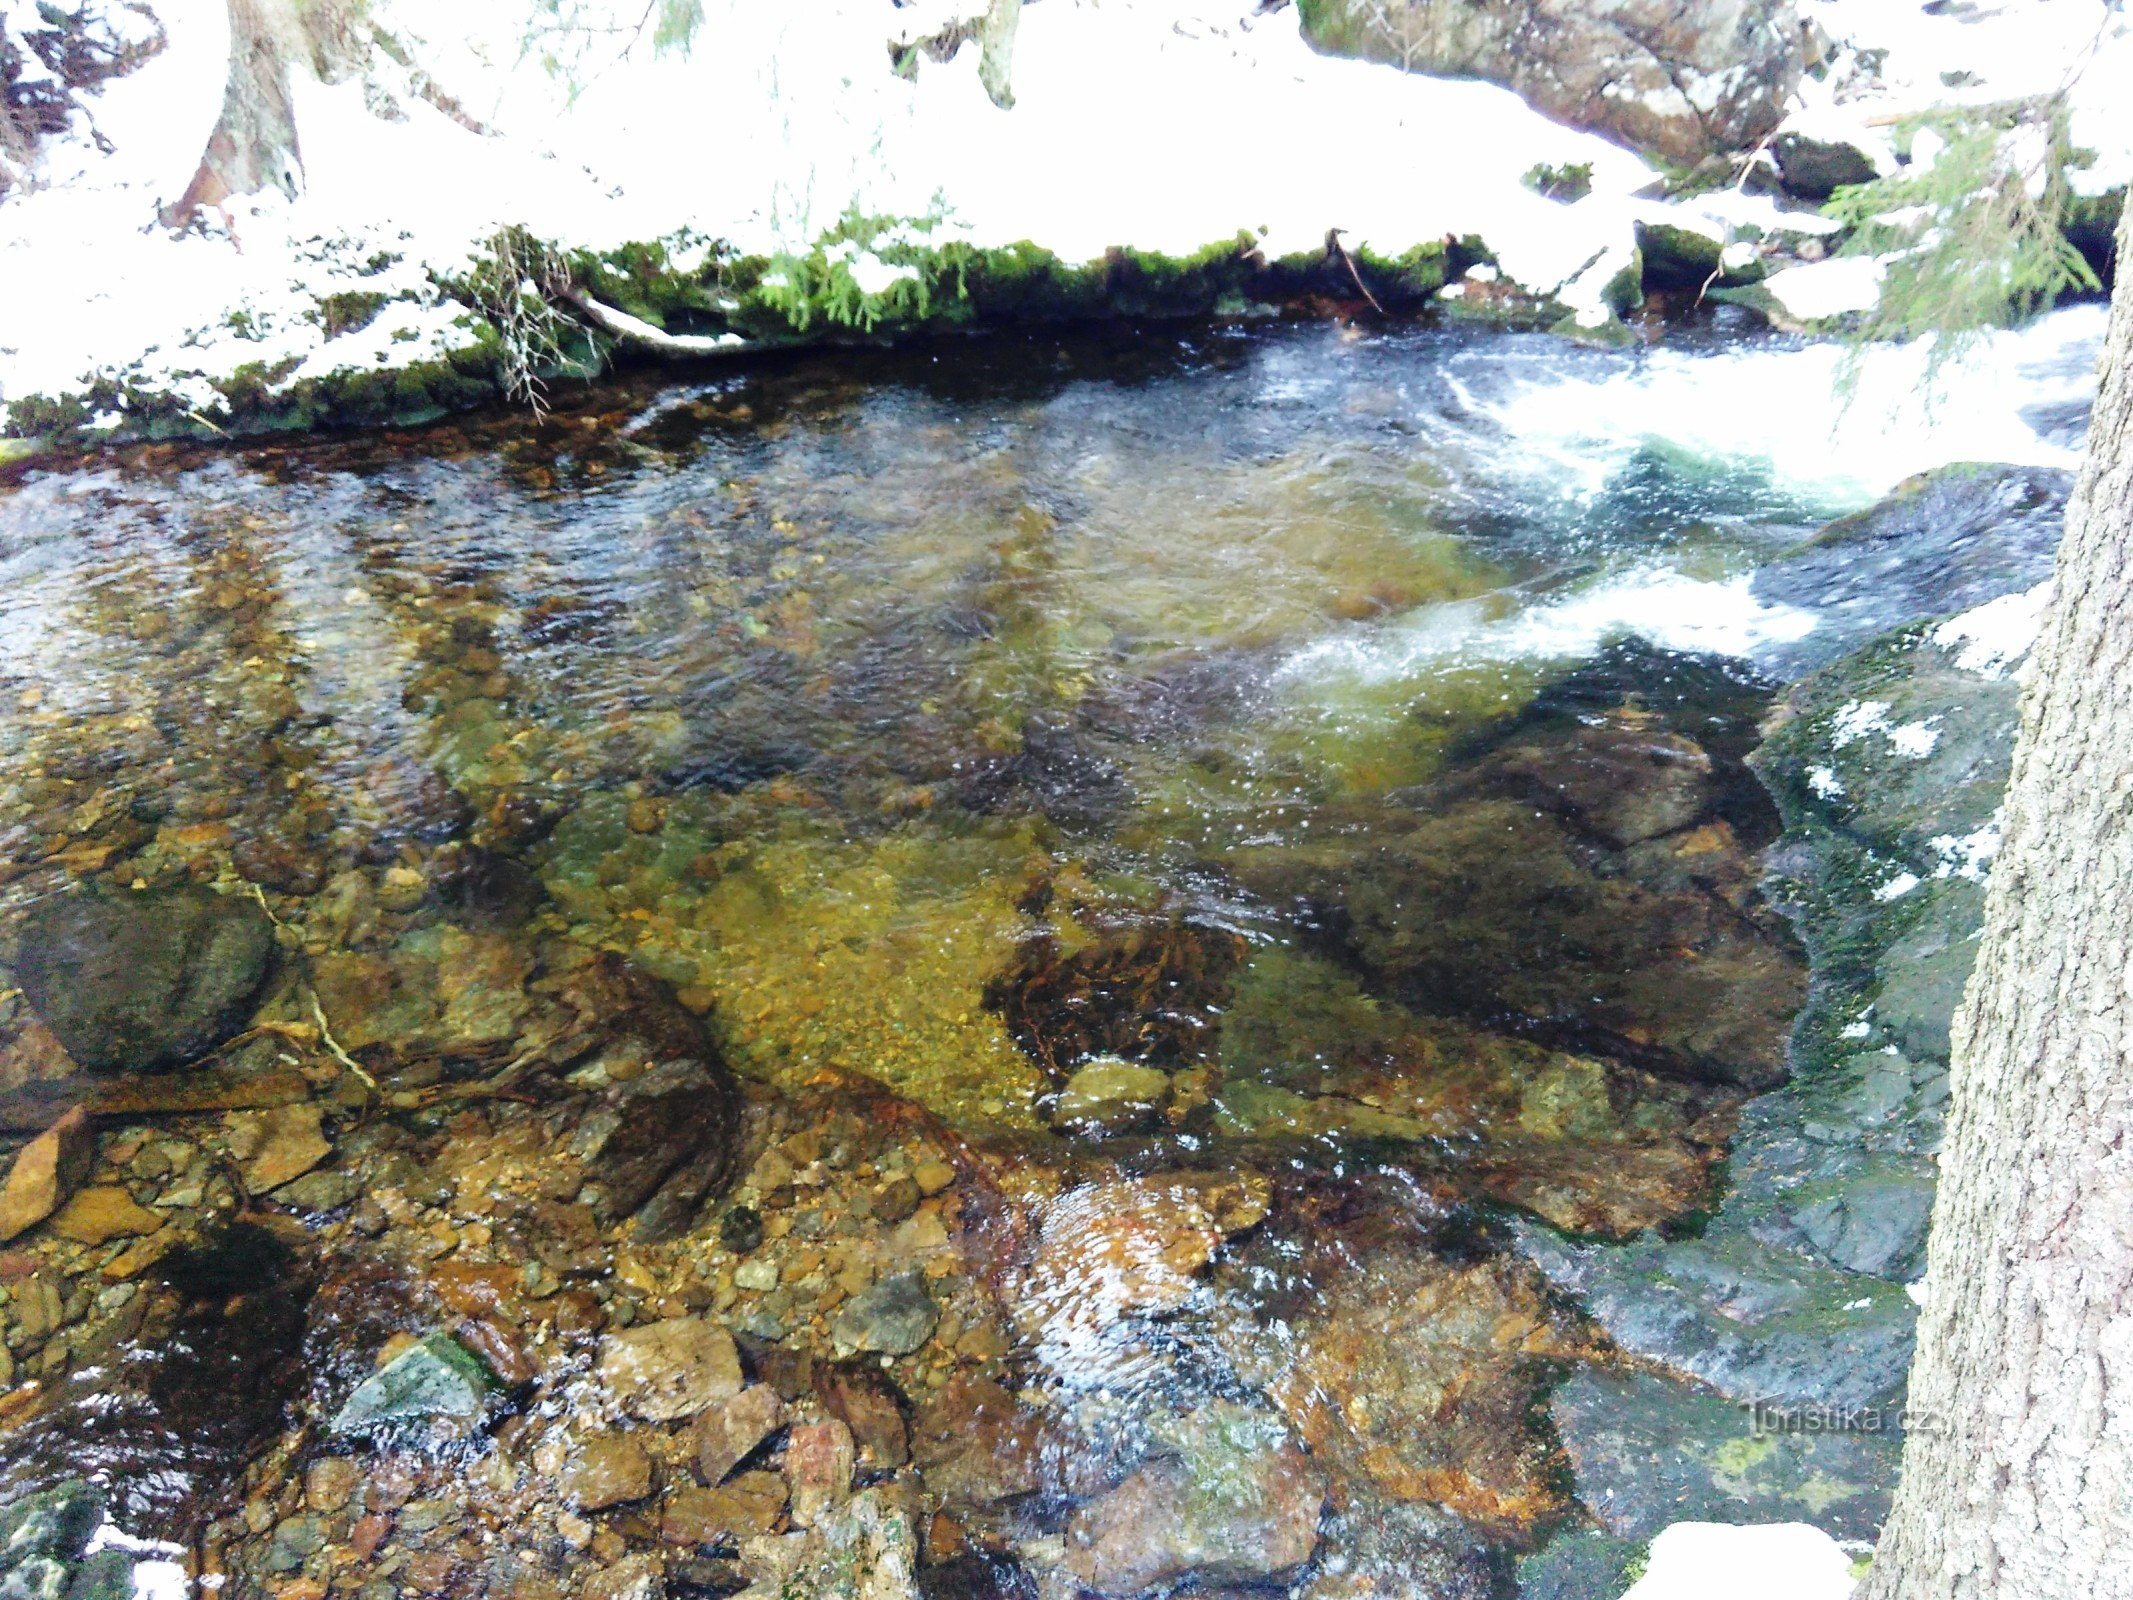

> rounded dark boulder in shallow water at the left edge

[{"left": 15, "top": 887, "right": 275, "bottom": 1071}]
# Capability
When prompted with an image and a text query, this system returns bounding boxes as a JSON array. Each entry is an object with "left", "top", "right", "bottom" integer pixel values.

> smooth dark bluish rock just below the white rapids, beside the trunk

[{"left": 1753, "top": 463, "right": 2073, "bottom": 678}]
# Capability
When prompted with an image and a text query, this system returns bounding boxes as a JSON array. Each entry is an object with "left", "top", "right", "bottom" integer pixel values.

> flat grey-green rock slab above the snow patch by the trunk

[{"left": 1551, "top": 1372, "right": 1903, "bottom": 1540}]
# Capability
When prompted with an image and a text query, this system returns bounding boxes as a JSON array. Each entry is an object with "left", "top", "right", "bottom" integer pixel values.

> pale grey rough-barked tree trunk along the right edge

[{"left": 1862, "top": 209, "right": 2133, "bottom": 1600}]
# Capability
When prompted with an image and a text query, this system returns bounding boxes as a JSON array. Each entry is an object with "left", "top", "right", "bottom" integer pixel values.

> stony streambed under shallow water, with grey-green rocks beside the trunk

[{"left": 0, "top": 333, "right": 2065, "bottom": 1600}]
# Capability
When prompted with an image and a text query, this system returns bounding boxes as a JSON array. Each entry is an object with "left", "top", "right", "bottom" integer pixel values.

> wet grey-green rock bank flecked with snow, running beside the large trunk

[{"left": 1521, "top": 467, "right": 2065, "bottom": 1596}]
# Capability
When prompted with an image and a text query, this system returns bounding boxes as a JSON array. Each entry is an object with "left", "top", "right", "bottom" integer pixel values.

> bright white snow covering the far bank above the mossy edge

[{"left": 0, "top": 0, "right": 2133, "bottom": 439}]
